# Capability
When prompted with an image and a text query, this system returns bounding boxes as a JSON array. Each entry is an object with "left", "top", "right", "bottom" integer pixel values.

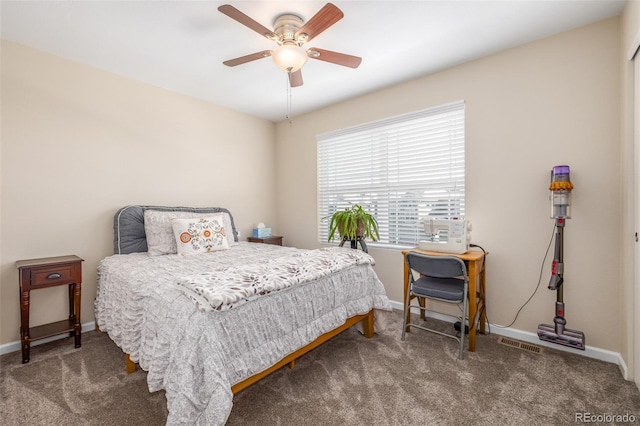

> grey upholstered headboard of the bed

[{"left": 113, "top": 206, "right": 238, "bottom": 254}]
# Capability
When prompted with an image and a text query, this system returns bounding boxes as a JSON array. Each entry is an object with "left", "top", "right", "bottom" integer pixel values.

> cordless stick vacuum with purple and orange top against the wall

[{"left": 538, "top": 166, "right": 585, "bottom": 350}]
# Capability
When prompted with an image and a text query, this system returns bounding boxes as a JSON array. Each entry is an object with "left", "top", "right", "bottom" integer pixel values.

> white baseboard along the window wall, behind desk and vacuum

[{"left": 391, "top": 301, "right": 631, "bottom": 380}]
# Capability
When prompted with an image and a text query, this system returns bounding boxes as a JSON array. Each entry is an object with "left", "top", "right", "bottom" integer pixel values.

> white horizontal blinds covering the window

[{"left": 317, "top": 101, "right": 465, "bottom": 247}]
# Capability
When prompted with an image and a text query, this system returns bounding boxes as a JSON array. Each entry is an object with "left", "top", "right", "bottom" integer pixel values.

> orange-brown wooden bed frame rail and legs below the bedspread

[{"left": 126, "top": 309, "right": 374, "bottom": 395}]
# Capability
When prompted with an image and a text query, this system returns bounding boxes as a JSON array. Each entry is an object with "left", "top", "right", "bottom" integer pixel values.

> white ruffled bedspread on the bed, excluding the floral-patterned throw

[{"left": 95, "top": 243, "right": 391, "bottom": 425}]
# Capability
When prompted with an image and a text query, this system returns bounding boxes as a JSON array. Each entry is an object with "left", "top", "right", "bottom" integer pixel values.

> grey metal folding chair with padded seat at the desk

[{"left": 402, "top": 252, "right": 469, "bottom": 359}]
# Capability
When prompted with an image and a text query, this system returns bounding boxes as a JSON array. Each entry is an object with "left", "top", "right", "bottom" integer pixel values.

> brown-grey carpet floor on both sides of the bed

[{"left": 0, "top": 311, "right": 640, "bottom": 426}]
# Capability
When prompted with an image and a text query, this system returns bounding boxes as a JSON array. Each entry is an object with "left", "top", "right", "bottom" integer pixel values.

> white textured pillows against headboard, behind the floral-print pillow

[{"left": 144, "top": 209, "right": 238, "bottom": 256}]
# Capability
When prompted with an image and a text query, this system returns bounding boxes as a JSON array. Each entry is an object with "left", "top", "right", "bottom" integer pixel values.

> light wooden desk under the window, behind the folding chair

[{"left": 402, "top": 247, "right": 489, "bottom": 352}]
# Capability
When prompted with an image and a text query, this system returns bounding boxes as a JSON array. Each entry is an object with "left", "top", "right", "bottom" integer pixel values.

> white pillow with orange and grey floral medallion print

[{"left": 171, "top": 214, "right": 229, "bottom": 256}]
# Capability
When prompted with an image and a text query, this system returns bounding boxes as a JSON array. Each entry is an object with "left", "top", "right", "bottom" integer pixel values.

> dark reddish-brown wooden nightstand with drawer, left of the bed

[{"left": 16, "top": 255, "right": 83, "bottom": 364}]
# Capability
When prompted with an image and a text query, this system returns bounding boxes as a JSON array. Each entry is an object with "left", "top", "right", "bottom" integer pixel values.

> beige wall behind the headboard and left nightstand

[{"left": 0, "top": 41, "right": 277, "bottom": 344}]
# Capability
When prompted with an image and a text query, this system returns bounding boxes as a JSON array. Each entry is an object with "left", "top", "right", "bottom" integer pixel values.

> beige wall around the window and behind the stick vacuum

[{"left": 276, "top": 18, "right": 623, "bottom": 352}]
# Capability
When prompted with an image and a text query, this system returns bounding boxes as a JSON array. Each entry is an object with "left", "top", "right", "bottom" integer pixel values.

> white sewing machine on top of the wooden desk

[{"left": 418, "top": 219, "right": 471, "bottom": 254}]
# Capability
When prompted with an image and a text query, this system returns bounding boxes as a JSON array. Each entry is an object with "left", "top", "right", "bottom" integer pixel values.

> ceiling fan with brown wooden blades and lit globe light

[{"left": 218, "top": 3, "right": 362, "bottom": 87}]
